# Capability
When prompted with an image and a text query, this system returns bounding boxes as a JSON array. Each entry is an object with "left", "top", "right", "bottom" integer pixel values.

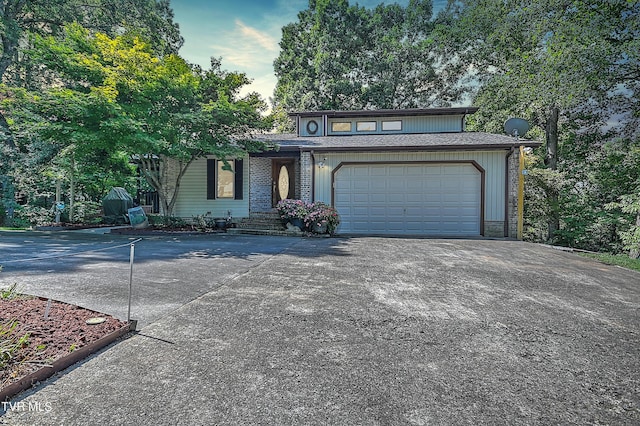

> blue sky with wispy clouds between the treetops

[{"left": 171, "top": 0, "right": 446, "bottom": 102}]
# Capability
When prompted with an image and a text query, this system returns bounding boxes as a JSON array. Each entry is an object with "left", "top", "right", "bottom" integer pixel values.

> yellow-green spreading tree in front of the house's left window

[{"left": 3, "top": 25, "right": 269, "bottom": 220}]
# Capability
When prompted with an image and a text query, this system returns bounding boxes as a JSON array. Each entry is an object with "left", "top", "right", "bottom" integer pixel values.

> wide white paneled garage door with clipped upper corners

[{"left": 334, "top": 163, "right": 481, "bottom": 236}]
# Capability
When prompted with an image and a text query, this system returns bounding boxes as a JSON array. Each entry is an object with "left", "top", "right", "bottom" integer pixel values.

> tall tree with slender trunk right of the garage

[{"left": 434, "top": 0, "right": 640, "bottom": 239}]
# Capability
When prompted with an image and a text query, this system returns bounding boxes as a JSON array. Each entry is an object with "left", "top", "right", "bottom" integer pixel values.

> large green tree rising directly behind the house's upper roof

[{"left": 274, "top": 0, "right": 443, "bottom": 111}]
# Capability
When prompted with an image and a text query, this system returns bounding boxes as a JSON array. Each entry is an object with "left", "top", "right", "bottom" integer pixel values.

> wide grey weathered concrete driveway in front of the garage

[{"left": 0, "top": 234, "right": 640, "bottom": 425}]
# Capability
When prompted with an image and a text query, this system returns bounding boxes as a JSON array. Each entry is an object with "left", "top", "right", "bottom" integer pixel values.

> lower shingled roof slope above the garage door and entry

[{"left": 259, "top": 132, "right": 541, "bottom": 155}]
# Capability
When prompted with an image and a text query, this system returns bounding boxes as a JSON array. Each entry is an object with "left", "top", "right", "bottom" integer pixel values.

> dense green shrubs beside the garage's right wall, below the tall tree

[{"left": 525, "top": 134, "right": 640, "bottom": 253}]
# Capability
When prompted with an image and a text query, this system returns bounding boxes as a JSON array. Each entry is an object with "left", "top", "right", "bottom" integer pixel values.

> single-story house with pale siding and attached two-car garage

[{"left": 166, "top": 108, "right": 539, "bottom": 237}]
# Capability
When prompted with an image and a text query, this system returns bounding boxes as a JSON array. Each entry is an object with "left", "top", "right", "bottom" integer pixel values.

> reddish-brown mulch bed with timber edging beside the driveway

[{"left": 0, "top": 295, "right": 126, "bottom": 398}]
